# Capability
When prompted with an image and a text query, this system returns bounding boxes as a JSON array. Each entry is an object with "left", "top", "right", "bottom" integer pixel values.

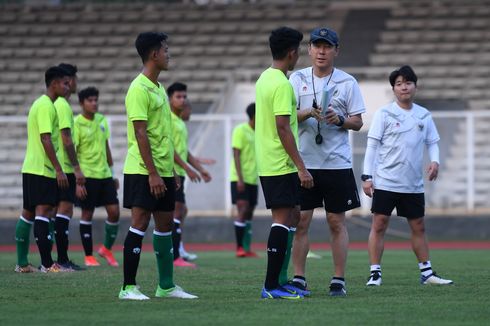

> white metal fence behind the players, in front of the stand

[{"left": 0, "top": 111, "right": 490, "bottom": 216}]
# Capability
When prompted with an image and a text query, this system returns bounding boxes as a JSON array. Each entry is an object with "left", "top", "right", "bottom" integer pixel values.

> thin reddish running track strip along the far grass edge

[{"left": 0, "top": 241, "right": 490, "bottom": 252}]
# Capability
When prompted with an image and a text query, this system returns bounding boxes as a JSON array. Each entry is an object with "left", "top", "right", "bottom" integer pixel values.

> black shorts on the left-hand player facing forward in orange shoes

[{"left": 78, "top": 178, "right": 119, "bottom": 210}]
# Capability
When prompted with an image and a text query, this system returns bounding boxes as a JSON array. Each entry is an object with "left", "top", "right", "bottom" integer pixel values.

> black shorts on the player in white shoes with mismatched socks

[{"left": 123, "top": 174, "right": 175, "bottom": 212}]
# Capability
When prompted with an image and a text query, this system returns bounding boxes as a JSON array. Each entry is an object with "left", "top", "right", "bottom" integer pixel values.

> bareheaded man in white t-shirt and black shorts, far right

[{"left": 361, "top": 66, "right": 453, "bottom": 286}]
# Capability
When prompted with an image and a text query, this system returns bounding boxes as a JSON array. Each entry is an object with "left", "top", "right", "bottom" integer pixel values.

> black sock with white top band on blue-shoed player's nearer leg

[{"left": 264, "top": 224, "right": 289, "bottom": 290}]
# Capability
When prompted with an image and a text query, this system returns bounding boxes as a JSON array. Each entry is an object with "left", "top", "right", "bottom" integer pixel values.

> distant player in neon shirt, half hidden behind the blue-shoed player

[{"left": 230, "top": 103, "right": 258, "bottom": 257}]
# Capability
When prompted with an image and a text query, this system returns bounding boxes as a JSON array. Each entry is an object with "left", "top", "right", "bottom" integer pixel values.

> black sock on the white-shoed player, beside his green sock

[{"left": 123, "top": 228, "right": 143, "bottom": 287}]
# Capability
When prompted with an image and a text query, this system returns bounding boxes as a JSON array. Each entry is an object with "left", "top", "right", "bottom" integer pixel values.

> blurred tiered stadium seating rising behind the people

[{"left": 0, "top": 0, "right": 490, "bottom": 214}]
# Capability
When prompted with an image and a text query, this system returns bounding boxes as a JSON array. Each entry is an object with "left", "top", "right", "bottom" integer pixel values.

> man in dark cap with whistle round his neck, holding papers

[{"left": 289, "top": 27, "right": 366, "bottom": 296}]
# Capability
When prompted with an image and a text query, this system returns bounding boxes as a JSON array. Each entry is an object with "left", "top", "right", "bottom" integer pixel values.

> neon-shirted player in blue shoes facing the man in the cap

[{"left": 255, "top": 27, "right": 313, "bottom": 299}]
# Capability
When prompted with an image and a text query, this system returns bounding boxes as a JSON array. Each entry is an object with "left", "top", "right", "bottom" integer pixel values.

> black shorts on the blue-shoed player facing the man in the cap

[{"left": 260, "top": 172, "right": 299, "bottom": 209}]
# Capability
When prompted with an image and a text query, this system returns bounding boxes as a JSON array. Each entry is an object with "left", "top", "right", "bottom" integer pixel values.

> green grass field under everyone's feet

[{"left": 0, "top": 250, "right": 490, "bottom": 325}]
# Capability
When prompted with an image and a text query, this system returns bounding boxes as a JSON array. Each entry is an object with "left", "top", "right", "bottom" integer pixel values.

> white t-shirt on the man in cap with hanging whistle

[{"left": 289, "top": 67, "right": 366, "bottom": 169}]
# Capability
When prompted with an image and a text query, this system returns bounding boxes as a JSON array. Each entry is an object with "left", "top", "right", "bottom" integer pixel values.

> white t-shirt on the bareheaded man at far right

[{"left": 368, "top": 102, "right": 440, "bottom": 193}]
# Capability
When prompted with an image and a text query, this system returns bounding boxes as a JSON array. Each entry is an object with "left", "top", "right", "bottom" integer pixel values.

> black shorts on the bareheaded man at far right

[{"left": 371, "top": 189, "right": 425, "bottom": 219}]
